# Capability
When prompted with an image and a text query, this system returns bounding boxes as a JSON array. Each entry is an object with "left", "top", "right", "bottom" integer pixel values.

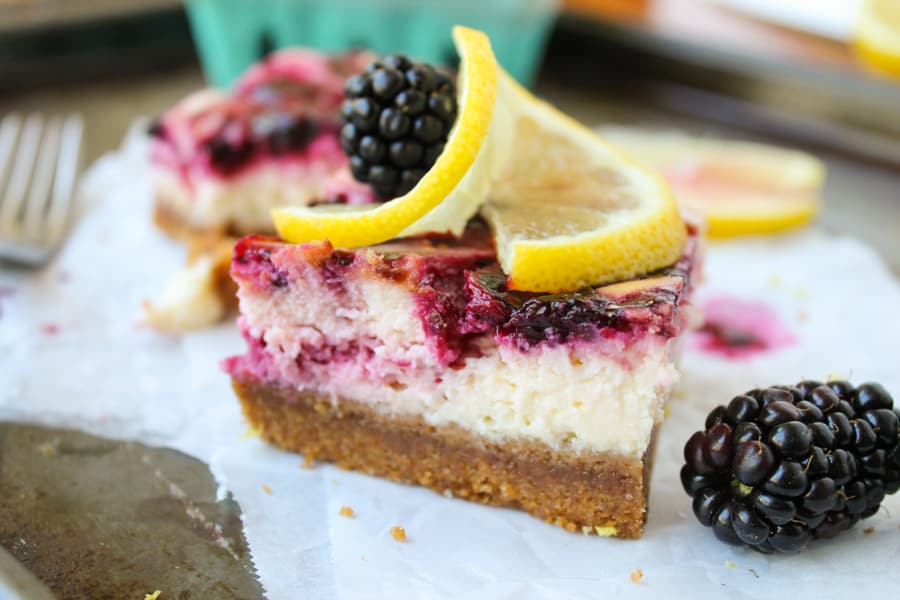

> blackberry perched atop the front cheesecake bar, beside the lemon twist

[{"left": 341, "top": 54, "right": 457, "bottom": 199}]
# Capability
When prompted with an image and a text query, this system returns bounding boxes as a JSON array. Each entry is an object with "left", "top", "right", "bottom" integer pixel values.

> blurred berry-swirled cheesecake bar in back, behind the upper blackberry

[{"left": 150, "top": 49, "right": 372, "bottom": 238}]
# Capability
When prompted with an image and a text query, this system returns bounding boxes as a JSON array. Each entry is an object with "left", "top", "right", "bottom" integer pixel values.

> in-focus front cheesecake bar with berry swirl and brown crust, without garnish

[{"left": 224, "top": 221, "right": 698, "bottom": 538}]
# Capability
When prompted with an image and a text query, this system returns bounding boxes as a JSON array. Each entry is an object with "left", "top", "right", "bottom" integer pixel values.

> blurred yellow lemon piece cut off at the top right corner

[{"left": 853, "top": 0, "right": 900, "bottom": 77}]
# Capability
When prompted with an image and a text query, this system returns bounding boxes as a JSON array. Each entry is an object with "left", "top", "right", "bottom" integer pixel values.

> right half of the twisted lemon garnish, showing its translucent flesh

[{"left": 482, "top": 74, "right": 687, "bottom": 292}]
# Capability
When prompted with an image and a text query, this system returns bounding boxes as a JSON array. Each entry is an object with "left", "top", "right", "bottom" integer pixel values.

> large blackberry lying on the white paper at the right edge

[{"left": 681, "top": 381, "right": 900, "bottom": 553}]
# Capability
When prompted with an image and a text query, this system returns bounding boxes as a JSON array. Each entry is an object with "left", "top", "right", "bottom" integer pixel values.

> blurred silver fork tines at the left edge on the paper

[{"left": 0, "top": 114, "right": 84, "bottom": 267}]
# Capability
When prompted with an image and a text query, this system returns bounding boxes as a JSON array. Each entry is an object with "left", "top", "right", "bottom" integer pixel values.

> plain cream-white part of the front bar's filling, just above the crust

[{"left": 340, "top": 343, "right": 678, "bottom": 458}]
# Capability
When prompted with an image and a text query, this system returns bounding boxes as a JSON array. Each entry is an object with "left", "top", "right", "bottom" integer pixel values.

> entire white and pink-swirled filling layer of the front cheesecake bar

[{"left": 240, "top": 274, "right": 678, "bottom": 458}]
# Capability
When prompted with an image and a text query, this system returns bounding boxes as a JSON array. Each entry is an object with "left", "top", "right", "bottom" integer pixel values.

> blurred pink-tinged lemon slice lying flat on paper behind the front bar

[{"left": 600, "top": 127, "right": 825, "bottom": 237}]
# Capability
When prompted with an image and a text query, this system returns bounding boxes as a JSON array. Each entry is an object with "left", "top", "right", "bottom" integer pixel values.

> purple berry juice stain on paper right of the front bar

[{"left": 691, "top": 295, "right": 797, "bottom": 360}]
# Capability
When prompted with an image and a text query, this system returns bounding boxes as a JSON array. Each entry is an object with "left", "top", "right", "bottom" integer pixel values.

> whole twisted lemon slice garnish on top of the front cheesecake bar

[{"left": 272, "top": 26, "right": 687, "bottom": 291}]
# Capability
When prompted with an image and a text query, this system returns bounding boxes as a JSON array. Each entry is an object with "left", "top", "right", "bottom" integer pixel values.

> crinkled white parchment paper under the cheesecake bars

[{"left": 0, "top": 132, "right": 900, "bottom": 600}]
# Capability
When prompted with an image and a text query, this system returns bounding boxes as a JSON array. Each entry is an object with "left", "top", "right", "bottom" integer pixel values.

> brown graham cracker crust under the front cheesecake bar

[{"left": 232, "top": 377, "right": 656, "bottom": 538}]
